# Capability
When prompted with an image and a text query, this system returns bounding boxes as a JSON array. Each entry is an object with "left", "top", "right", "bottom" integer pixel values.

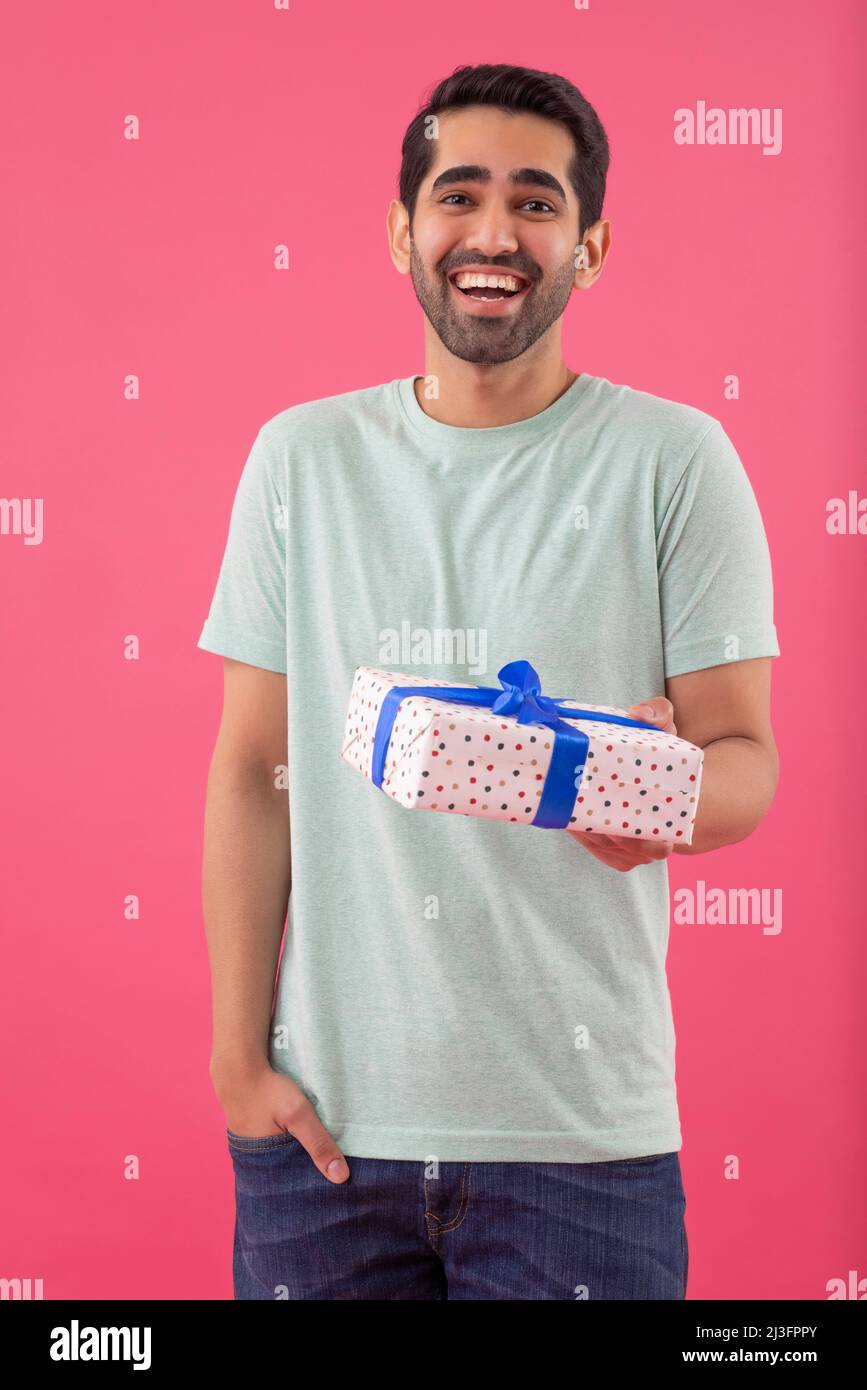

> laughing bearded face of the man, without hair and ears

[{"left": 410, "top": 106, "right": 578, "bottom": 364}]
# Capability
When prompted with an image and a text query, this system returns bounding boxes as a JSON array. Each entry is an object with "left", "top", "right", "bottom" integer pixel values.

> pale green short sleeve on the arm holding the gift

[{"left": 657, "top": 420, "right": 779, "bottom": 676}]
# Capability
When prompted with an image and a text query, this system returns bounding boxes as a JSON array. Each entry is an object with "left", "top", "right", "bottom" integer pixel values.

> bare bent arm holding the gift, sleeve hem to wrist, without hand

[{"left": 666, "top": 656, "right": 779, "bottom": 855}]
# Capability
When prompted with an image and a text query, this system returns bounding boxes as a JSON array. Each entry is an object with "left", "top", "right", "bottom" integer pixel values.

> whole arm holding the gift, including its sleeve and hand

[{"left": 572, "top": 420, "right": 779, "bottom": 870}]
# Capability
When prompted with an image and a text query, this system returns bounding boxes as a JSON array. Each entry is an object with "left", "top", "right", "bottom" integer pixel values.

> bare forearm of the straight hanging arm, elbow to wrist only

[{"left": 201, "top": 749, "right": 290, "bottom": 1077}]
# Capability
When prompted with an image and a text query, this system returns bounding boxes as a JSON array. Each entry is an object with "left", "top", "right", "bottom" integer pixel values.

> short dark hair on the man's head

[{"left": 399, "top": 63, "right": 610, "bottom": 236}]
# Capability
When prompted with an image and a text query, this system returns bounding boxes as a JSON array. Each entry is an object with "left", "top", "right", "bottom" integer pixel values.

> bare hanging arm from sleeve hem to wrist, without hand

[{"left": 201, "top": 657, "right": 290, "bottom": 1088}]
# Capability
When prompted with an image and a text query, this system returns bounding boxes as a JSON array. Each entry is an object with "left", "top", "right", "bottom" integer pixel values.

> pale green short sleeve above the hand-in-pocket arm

[{"left": 196, "top": 427, "right": 286, "bottom": 673}]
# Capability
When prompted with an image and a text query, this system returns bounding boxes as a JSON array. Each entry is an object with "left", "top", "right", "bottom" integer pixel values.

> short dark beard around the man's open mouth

[{"left": 410, "top": 242, "right": 575, "bottom": 367}]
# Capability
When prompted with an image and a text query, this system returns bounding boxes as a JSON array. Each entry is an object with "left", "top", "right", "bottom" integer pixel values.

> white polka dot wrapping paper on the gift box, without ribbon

[{"left": 340, "top": 666, "right": 703, "bottom": 845}]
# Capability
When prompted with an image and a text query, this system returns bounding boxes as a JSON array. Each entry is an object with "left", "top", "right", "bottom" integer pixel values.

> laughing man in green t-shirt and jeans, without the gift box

[{"left": 199, "top": 67, "right": 779, "bottom": 1300}]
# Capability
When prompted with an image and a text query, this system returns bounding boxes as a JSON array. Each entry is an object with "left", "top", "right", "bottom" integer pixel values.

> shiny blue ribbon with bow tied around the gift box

[{"left": 371, "top": 660, "right": 660, "bottom": 830}]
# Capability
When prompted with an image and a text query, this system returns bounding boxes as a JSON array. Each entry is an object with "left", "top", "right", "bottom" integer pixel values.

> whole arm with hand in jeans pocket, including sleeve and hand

[{"left": 199, "top": 427, "right": 349, "bottom": 1183}]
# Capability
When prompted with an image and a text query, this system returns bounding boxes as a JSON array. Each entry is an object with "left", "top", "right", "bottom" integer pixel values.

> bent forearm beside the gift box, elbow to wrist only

[{"left": 674, "top": 738, "right": 779, "bottom": 855}]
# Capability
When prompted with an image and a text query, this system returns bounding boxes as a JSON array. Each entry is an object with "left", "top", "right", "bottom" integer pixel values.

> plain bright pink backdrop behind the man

[{"left": 0, "top": 0, "right": 867, "bottom": 1300}]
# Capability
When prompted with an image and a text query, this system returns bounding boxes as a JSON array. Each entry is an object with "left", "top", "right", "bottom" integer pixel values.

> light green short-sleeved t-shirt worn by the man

[{"left": 199, "top": 373, "right": 779, "bottom": 1162}]
